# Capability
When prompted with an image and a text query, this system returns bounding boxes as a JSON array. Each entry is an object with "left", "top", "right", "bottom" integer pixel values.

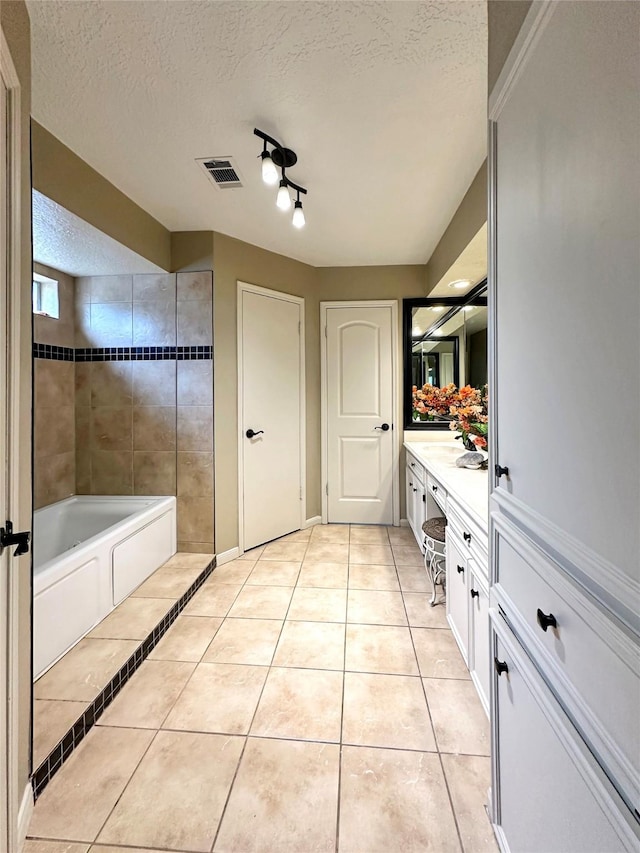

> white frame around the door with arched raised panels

[{"left": 320, "top": 299, "right": 401, "bottom": 527}]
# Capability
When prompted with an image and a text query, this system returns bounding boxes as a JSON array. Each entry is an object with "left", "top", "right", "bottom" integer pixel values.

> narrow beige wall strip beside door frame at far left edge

[{"left": 0, "top": 0, "right": 31, "bottom": 818}]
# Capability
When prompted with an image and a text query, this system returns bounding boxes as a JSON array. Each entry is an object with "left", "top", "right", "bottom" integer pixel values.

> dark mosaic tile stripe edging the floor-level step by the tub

[{"left": 31, "top": 557, "right": 216, "bottom": 801}]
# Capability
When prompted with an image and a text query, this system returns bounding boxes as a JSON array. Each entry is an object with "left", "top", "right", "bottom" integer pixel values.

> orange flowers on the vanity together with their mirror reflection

[{"left": 412, "top": 383, "right": 489, "bottom": 450}]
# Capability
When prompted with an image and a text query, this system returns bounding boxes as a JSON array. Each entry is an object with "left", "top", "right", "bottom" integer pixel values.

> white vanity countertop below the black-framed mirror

[{"left": 404, "top": 440, "right": 489, "bottom": 531}]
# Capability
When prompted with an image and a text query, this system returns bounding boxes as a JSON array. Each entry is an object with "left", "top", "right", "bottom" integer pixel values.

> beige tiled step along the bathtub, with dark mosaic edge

[{"left": 32, "top": 553, "right": 215, "bottom": 798}]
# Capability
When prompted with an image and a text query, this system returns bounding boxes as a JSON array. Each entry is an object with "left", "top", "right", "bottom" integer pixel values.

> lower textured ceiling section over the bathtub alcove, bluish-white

[{"left": 32, "top": 190, "right": 164, "bottom": 276}]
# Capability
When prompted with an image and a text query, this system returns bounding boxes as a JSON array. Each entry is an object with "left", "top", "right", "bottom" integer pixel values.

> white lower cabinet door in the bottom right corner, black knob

[{"left": 493, "top": 616, "right": 638, "bottom": 853}]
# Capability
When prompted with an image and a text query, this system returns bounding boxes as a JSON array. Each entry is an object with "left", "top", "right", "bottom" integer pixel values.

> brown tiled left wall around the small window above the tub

[{"left": 33, "top": 264, "right": 76, "bottom": 509}]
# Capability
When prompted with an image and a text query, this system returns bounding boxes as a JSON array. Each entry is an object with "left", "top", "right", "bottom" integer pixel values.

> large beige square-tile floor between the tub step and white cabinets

[{"left": 24, "top": 525, "right": 497, "bottom": 853}]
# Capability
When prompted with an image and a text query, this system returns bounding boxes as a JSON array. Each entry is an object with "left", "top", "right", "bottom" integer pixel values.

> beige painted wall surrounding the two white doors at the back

[{"left": 214, "top": 246, "right": 425, "bottom": 553}]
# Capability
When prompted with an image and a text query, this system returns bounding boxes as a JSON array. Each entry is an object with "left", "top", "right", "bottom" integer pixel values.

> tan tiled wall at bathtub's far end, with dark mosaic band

[{"left": 34, "top": 271, "right": 214, "bottom": 553}]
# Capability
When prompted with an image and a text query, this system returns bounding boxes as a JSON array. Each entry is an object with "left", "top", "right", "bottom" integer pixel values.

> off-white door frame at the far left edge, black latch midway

[{"left": 0, "top": 30, "right": 33, "bottom": 850}]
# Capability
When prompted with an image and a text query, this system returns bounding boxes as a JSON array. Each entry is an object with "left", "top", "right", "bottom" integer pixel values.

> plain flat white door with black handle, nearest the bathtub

[{"left": 239, "top": 285, "right": 303, "bottom": 550}]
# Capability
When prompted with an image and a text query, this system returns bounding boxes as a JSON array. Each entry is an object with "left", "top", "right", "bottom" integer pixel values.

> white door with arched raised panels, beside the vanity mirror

[{"left": 326, "top": 306, "right": 394, "bottom": 524}]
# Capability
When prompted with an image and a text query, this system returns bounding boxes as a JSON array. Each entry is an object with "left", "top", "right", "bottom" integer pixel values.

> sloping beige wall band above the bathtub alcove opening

[{"left": 31, "top": 121, "right": 171, "bottom": 270}]
